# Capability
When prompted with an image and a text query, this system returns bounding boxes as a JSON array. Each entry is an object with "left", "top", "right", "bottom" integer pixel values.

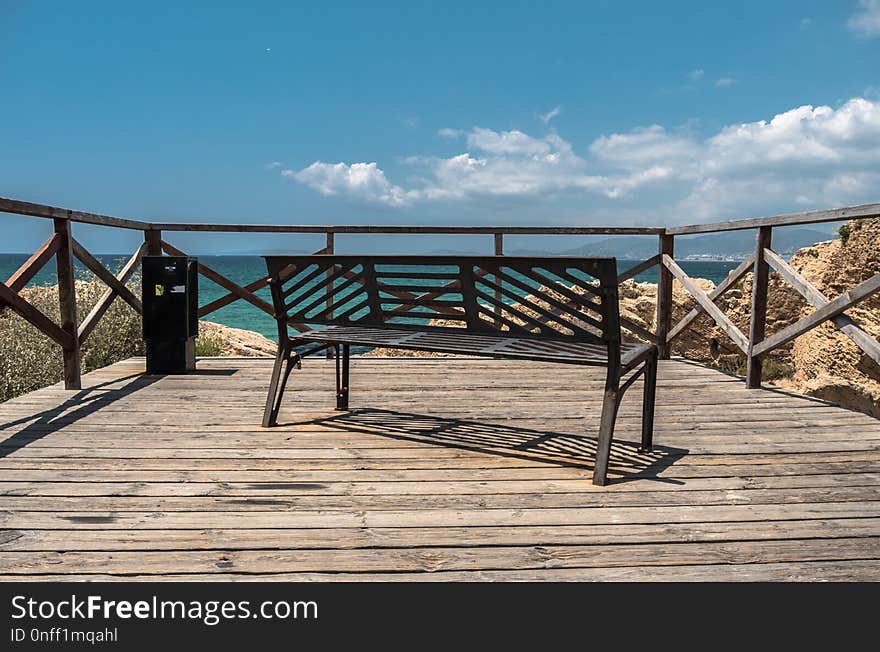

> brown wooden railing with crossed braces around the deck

[{"left": 0, "top": 197, "right": 880, "bottom": 389}]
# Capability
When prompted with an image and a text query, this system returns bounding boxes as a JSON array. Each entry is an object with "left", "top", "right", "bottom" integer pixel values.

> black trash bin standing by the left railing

[{"left": 141, "top": 256, "right": 199, "bottom": 374}]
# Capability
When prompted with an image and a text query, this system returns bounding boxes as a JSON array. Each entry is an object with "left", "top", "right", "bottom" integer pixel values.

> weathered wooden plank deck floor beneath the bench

[{"left": 0, "top": 358, "right": 880, "bottom": 581}]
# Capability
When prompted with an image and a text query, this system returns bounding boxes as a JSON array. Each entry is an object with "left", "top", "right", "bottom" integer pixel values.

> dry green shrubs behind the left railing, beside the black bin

[{"left": 0, "top": 277, "right": 144, "bottom": 401}]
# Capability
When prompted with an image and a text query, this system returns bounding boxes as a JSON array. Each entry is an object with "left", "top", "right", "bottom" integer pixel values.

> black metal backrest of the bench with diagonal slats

[{"left": 265, "top": 254, "right": 620, "bottom": 345}]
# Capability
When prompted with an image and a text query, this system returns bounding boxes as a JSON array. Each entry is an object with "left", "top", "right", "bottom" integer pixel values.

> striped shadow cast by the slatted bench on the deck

[{"left": 308, "top": 408, "right": 688, "bottom": 485}]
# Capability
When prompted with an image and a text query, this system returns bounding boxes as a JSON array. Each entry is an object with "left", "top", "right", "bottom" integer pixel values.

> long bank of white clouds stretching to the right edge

[{"left": 281, "top": 98, "right": 880, "bottom": 221}]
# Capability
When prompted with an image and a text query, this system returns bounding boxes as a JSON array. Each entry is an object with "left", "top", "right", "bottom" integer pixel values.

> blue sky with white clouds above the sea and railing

[{"left": 0, "top": 0, "right": 880, "bottom": 251}]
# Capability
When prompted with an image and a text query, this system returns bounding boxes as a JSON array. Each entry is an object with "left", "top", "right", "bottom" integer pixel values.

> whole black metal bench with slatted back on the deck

[{"left": 263, "top": 255, "right": 657, "bottom": 485}]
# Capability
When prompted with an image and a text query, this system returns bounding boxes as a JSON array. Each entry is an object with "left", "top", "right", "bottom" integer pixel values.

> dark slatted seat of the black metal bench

[{"left": 291, "top": 326, "right": 654, "bottom": 370}]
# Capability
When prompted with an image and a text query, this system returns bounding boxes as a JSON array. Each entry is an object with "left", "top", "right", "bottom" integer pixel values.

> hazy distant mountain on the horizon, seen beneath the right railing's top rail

[{"left": 509, "top": 228, "right": 833, "bottom": 260}]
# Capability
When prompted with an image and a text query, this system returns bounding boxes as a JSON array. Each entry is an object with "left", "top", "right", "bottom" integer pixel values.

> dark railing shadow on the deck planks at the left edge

[{"left": 0, "top": 373, "right": 164, "bottom": 458}]
